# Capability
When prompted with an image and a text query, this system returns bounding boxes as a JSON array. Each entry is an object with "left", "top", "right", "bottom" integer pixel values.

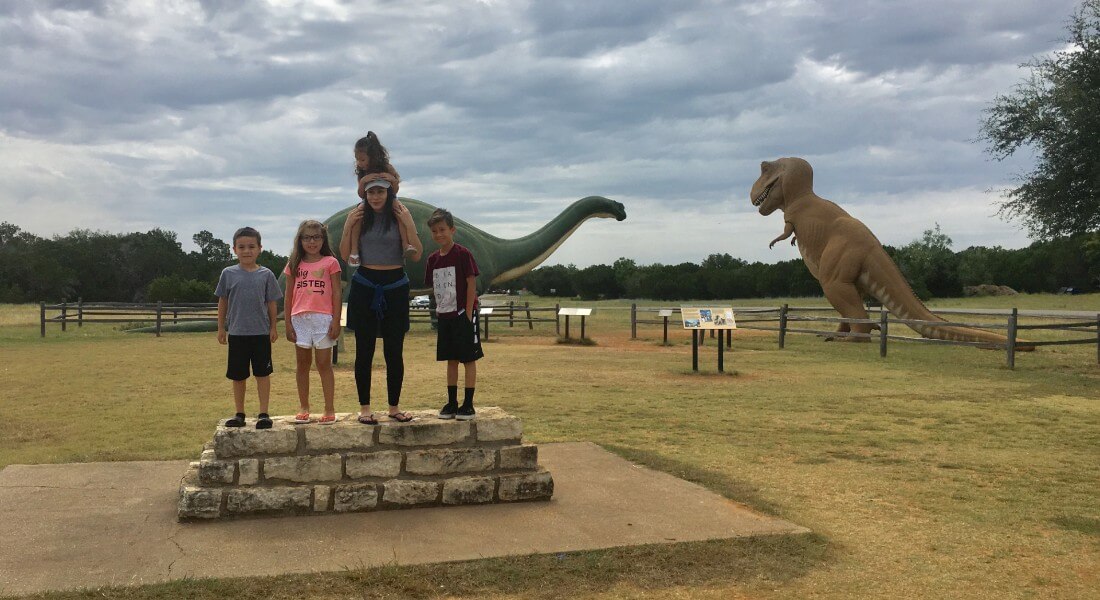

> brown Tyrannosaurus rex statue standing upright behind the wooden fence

[{"left": 749, "top": 157, "right": 1034, "bottom": 350}]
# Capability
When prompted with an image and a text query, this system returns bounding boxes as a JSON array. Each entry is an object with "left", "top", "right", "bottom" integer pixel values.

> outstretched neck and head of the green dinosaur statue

[{"left": 490, "top": 196, "right": 615, "bottom": 283}]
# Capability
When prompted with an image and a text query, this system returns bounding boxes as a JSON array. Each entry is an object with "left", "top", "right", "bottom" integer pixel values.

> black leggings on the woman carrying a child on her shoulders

[{"left": 348, "top": 266, "right": 409, "bottom": 406}]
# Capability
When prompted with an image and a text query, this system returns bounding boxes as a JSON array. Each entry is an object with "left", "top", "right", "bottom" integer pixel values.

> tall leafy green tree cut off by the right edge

[{"left": 979, "top": 0, "right": 1100, "bottom": 239}]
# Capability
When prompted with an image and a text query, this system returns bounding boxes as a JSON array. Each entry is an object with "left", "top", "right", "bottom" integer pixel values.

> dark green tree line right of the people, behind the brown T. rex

[{"left": 508, "top": 225, "right": 1100, "bottom": 301}]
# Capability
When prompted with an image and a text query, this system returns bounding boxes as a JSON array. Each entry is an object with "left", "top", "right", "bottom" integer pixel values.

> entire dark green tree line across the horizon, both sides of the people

[{"left": 0, "top": 222, "right": 1100, "bottom": 303}]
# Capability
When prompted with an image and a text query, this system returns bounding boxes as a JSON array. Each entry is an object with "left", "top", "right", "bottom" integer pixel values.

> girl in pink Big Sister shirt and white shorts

[{"left": 283, "top": 220, "right": 343, "bottom": 424}]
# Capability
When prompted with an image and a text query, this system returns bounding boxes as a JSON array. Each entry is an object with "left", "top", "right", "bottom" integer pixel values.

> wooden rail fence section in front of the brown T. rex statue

[{"left": 630, "top": 304, "right": 1100, "bottom": 369}]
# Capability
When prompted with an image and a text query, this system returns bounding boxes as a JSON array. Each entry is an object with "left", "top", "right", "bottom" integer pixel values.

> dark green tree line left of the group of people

[{"left": 0, "top": 222, "right": 286, "bottom": 303}]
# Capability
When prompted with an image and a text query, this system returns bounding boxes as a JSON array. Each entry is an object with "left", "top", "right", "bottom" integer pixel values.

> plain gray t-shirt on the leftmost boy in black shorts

[{"left": 213, "top": 264, "right": 283, "bottom": 336}]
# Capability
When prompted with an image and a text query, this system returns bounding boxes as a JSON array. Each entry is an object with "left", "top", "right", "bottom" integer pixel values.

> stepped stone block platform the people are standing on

[{"left": 178, "top": 406, "right": 553, "bottom": 521}]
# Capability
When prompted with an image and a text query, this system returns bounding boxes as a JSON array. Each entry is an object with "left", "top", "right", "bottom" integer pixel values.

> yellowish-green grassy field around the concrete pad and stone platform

[{"left": 0, "top": 294, "right": 1100, "bottom": 599}]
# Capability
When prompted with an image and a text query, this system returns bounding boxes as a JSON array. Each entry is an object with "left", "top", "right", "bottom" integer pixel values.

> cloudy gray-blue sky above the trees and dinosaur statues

[{"left": 0, "top": 0, "right": 1077, "bottom": 266}]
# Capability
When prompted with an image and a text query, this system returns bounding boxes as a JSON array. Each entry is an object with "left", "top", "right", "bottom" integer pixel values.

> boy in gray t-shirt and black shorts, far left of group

[{"left": 215, "top": 227, "right": 283, "bottom": 429}]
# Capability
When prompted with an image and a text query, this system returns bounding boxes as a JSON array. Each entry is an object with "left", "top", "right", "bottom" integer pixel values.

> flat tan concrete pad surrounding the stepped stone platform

[{"left": 0, "top": 443, "right": 809, "bottom": 594}]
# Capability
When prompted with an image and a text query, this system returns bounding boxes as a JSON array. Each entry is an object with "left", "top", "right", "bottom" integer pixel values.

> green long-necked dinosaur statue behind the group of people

[{"left": 132, "top": 196, "right": 626, "bottom": 332}]
